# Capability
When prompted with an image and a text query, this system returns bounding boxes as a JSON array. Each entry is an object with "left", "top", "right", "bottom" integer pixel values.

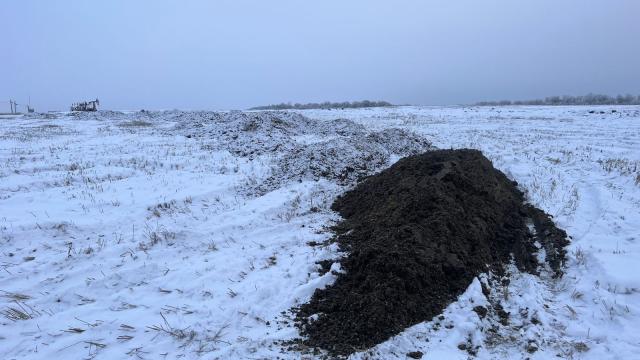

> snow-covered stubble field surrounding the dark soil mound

[{"left": 0, "top": 106, "right": 640, "bottom": 359}]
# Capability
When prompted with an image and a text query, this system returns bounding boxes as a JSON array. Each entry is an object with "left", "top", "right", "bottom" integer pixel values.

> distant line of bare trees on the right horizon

[{"left": 475, "top": 94, "right": 640, "bottom": 106}]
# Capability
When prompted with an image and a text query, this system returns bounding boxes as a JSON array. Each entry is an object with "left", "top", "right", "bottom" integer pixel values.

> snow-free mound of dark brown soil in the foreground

[{"left": 297, "top": 150, "right": 568, "bottom": 355}]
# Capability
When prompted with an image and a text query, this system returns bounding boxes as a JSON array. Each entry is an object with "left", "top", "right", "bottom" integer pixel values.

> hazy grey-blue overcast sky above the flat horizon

[{"left": 0, "top": 0, "right": 640, "bottom": 112}]
